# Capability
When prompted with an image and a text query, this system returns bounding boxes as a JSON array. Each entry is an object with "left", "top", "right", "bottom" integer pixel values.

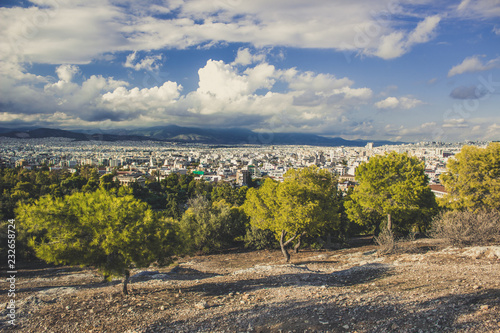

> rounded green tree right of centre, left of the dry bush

[{"left": 345, "top": 152, "right": 437, "bottom": 233}]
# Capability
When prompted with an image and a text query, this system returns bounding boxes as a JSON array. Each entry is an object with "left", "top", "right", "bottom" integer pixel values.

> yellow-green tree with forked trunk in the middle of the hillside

[{"left": 243, "top": 166, "right": 339, "bottom": 262}]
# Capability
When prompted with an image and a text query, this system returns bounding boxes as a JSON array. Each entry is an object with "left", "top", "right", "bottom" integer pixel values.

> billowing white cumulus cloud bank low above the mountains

[{"left": 0, "top": 52, "right": 373, "bottom": 132}]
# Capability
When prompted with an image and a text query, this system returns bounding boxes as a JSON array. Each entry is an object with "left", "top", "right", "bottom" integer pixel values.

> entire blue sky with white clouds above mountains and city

[{"left": 0, "top": 0, "right": 500, "bottom": 142}]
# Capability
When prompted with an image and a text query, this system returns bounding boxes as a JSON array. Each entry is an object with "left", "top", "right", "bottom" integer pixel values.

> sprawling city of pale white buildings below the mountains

[{"left": 0, "top": 134, "right": 488, "bottom": 196}]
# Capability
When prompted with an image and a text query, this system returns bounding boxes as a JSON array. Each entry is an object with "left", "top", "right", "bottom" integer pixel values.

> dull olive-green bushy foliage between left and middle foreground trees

[{"left": 180, "top": 196, "right": 248, "bottom": 253}]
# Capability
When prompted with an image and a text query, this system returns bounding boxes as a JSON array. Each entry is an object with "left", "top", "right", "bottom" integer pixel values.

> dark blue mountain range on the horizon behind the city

[{"left": 0, "top": 125, "right": 401, "bottom": 147}]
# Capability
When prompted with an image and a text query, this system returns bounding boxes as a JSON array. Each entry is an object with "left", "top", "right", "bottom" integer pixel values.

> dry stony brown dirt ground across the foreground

[{"left": 0, "top": 240, "right": 500, "bottom": 333}]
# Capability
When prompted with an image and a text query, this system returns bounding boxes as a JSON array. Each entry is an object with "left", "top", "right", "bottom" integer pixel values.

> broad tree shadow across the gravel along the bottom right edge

[{"left": 145, "top": 289, "right": 500, "bottom": 333}]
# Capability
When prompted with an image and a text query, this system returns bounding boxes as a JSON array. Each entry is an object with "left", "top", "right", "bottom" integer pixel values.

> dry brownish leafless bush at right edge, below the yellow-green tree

[{"left": 430, "top": 210, "right": 500, "bottom": 246}]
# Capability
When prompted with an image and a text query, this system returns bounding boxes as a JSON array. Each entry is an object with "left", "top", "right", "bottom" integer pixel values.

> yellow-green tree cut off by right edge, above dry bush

[{"left": 441, "top": 142, "right": 500, "bottom": 212}]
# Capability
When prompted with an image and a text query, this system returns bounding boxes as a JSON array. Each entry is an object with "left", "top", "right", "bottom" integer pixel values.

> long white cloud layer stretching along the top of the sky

[{"left": 0, "top": 0, "right": 446, "bottom": 66}]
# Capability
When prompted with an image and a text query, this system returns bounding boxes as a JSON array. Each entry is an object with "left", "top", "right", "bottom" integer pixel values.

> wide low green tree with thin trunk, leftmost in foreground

[{"left": 16, "top": 189, "right": 176, "bottom": 294}]
